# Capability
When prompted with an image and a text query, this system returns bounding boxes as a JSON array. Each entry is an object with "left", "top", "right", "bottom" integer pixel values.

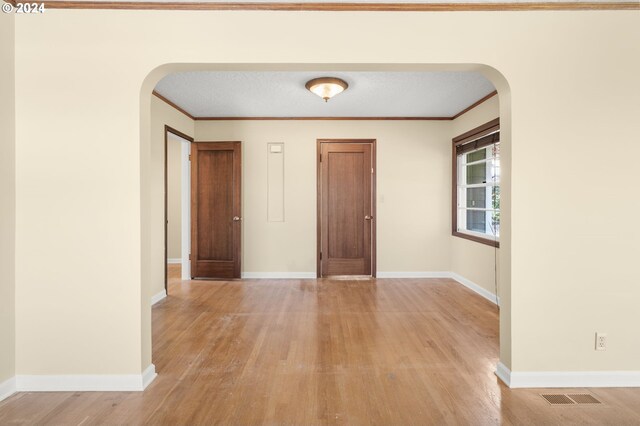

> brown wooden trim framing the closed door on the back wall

[{"left": 316, "top": 139, "right": 378, "bottom": 278}]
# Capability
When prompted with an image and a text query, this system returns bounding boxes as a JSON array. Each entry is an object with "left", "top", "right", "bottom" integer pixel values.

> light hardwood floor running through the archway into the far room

[{"left": 0, "top": 266, "right": 640, "bottom": 425}]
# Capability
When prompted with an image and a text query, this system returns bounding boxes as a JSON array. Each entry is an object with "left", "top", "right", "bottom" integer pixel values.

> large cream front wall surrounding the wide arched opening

[{"left": 11, "top": 10, "right": 640, "bottom": 374}]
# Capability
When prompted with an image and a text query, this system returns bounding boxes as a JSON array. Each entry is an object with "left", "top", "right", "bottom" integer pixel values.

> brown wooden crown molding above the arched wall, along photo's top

[{"left": 15, "top": 0, "right": 640, "bottom": 12}]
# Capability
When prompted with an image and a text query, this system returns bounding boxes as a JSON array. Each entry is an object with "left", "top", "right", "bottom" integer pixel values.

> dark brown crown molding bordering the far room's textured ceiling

[{"left": 151, "top": 90, "right": 498, "bottom": 121}]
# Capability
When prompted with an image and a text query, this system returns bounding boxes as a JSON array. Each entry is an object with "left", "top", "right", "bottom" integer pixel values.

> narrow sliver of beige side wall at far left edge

[{"left": 0, "top": 13, "right": 16, "bottom": 384}]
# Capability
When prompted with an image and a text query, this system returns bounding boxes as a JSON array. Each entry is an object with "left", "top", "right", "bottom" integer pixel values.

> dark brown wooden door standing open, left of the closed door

[{"left": 191, "top": 142, "right": 242, "bottom": 278}]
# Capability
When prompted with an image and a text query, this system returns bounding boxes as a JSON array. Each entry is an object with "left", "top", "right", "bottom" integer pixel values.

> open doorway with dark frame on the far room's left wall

[{"left": 164, "top": 126, "right": 193, "bottom": 293}]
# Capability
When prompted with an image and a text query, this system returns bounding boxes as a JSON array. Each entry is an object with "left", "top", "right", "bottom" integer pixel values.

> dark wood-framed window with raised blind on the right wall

[{"left": 452, "top": 119, "right": 500, "bottom": 247}]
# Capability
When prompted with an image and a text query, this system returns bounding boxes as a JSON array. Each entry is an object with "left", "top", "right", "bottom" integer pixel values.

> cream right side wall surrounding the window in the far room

[{"left": 448, "top": 96, "right": 500, "bottom": 294}]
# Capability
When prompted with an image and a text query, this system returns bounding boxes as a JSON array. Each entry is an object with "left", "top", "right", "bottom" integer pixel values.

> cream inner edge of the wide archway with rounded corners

[{"left": 140, "top": 64, "right": 511, "bottom": 380}]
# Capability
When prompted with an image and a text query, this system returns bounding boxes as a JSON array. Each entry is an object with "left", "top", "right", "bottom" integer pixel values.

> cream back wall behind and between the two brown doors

[{"left": 196, "top": 120, "right": 451, "bottom": 276}]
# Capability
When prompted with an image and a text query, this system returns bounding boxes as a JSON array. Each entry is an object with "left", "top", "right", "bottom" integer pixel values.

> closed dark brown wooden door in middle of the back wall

[{"left": 318, "top": 140, "right": 375, "bottom": 277}]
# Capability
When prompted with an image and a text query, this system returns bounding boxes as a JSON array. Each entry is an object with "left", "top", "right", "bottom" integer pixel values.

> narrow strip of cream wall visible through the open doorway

[{"left": 167, "top": 134, "right": 182, "bottom": 261}]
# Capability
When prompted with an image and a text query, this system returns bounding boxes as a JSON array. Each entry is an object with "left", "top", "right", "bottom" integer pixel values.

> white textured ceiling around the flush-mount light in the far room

[{"left": 156, "top": 71, "right": 495, "bottom": 117}]
